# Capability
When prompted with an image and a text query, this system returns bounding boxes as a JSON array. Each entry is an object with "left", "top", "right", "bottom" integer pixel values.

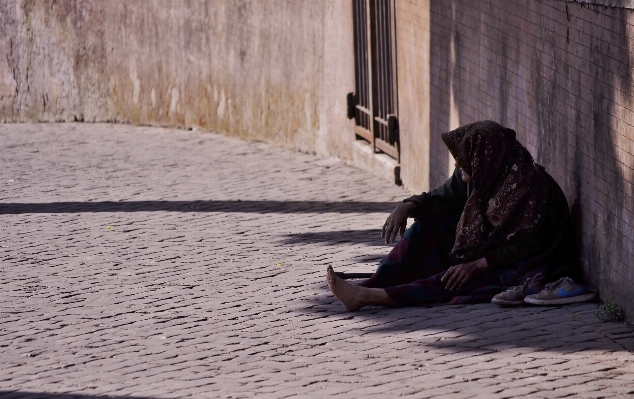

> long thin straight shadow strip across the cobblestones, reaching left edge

[{"left": 0, "top": 200, "right": 394, "bottom": 215}]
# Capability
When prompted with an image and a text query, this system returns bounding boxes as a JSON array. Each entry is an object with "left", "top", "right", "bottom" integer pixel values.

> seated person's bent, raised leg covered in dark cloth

[{"left": 360, "top": 212, "right": 460, "bottom": 288}]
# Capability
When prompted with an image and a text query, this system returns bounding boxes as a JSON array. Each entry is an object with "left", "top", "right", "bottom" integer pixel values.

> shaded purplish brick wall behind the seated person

[{"left": 430, "top": 0, "right": 634, "bottom": 318}]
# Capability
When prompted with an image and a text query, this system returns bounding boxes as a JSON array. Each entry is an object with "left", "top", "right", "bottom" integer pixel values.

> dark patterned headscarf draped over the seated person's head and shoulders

[{"left": 442, "top": 121, "right": 548, "bottom": 261}]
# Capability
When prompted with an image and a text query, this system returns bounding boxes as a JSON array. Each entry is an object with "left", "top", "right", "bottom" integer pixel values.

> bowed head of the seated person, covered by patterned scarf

[{"left": 441, "top": 121, "right": 530, "bottom": 186}]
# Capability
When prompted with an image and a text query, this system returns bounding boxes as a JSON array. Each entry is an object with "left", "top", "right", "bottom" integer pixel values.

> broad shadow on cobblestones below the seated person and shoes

[{"left": 302, "top": 280, "right": 634, "bottom": 353}]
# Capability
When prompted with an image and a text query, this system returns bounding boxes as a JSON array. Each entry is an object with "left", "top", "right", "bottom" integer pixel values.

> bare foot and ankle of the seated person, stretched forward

[{"left": 326, "top": 266, "right": 397, "bottom": 312}]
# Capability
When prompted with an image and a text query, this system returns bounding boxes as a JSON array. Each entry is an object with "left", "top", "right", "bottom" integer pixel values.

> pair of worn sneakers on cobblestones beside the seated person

[{"left": 491, "top": 273, "right": 597, "bottom": 306}]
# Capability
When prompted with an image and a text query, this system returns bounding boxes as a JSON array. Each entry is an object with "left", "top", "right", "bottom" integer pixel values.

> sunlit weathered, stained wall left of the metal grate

[{"left": 0, "top": 0, "right": 354, "bottom": 158}]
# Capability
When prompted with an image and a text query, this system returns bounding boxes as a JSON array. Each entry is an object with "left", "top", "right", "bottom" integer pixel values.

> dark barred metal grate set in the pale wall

[{"left": 352, "top": 0, "right": 400, "bottom": 161}]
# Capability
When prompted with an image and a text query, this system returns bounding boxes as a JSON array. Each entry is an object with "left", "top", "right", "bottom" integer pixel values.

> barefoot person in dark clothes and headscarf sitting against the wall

[{"left": 327, "top": 121, "right": 573, "bottom": 311}]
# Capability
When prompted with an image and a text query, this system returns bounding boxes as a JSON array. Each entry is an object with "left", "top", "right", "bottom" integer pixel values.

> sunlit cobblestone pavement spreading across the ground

[{"left": 0, "top": 123, "right": 634, "bottom": 399}]
